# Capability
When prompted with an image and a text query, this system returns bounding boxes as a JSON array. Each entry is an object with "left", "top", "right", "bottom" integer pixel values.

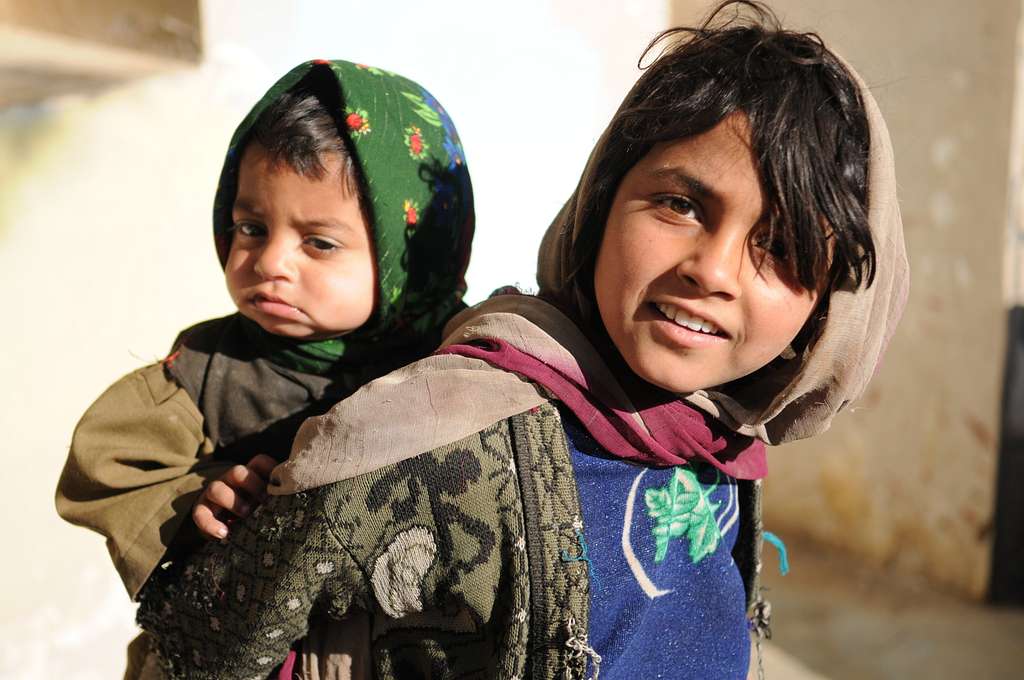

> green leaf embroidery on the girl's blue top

[{"left": 644, "top": 466, "right": 722, "bottom": 564}]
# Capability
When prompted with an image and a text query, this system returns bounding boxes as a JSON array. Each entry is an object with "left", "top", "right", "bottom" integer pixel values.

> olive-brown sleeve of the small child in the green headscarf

[{"left": 56, "top": 364, "right": 230, "bottom": 598}]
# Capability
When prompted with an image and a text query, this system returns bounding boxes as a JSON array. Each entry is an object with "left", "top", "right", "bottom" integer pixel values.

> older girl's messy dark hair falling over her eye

[{"left": 568, "top": 0, "right": 874, "bottom": 297}]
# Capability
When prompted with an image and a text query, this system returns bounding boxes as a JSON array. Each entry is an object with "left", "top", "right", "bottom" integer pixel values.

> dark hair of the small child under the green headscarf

[{"left": 246, "top": 90, "right": 359, "bottom": 196}]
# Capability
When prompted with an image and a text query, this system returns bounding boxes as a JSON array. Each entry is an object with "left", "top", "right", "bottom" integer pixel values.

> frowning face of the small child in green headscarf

[{"left": 224, "top": 143, "right": 377, "bottom": 340}]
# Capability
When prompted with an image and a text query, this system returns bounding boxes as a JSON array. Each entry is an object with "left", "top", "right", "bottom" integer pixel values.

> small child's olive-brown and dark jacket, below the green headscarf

[{"left": 56, "top": 314, "right": 430, "bottom": 598}]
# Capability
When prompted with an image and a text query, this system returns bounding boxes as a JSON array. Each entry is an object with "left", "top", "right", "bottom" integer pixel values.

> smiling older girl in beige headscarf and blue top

[{"left": 139, "top": 2, "right": 908, "bottom": 680}]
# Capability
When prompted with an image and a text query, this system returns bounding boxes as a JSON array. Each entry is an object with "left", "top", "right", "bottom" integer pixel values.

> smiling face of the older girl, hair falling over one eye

[{"left": 594, "top": 114, "right": 817, "bottom": 392}]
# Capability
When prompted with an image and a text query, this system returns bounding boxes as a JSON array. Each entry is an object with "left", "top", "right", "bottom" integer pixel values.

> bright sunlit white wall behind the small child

[{"left": 0, "top": 0, "right": 669, "bottom": 680}]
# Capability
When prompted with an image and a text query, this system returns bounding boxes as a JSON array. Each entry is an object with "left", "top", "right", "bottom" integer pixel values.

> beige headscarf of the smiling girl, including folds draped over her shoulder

[{"left": 270, "top": 58, "right": 909, "bottom": 494}]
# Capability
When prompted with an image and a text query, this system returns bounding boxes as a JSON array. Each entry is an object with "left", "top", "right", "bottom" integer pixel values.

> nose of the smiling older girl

[{"left": 676, "top": 228, "right": 746, "bottom": 299}]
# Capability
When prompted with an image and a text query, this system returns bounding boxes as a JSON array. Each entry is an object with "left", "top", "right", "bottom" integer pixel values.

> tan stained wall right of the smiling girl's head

[{"left": 673, "top": 0, "right": 1020, "bottom": 597}]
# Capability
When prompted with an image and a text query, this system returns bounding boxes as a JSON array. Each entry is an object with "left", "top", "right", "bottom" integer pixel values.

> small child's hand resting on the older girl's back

[{"left": 193, "top": 454, "right": 278, "bottom": 540}]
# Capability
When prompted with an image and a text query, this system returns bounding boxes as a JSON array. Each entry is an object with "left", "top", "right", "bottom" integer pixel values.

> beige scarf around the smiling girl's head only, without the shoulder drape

[{"left": 538, "top": 65, "right": 910, "bottom": 444}]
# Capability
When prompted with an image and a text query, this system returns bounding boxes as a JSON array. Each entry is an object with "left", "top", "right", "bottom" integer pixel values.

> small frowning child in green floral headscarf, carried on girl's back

[{"left": 56, "top": 60, "right": 473, "bottom": 675}]
